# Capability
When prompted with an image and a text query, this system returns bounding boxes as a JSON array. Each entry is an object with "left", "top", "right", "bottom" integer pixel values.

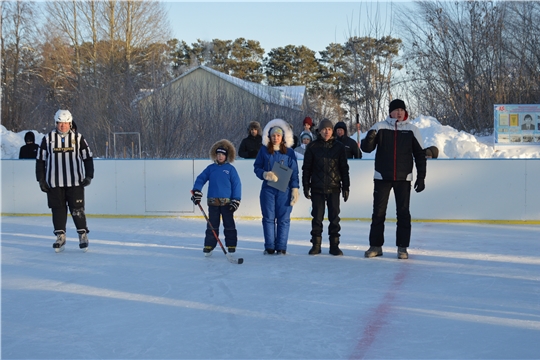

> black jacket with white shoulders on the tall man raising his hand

[{"left": 360, "top": 117, "right": 426, "bottom": 181}]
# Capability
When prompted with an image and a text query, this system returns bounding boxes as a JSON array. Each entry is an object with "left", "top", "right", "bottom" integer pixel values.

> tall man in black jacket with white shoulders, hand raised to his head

[{"left": 361, "top": 99, "right": 426, "bottom": 259}]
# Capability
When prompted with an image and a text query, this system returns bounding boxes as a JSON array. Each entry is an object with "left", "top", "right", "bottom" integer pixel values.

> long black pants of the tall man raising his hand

[{"left": 369, "top": 180, "right": 411, "bottom": 247}]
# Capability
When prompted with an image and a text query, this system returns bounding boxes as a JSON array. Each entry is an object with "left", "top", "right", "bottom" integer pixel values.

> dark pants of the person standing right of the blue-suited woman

[{"left": 311, "top": 192, "right": 341, "bottom": 242}]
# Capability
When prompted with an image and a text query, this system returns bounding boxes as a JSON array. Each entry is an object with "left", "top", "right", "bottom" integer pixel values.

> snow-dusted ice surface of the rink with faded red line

[{"left": 1, "top": 216, "right": 540, "bottom": 359}]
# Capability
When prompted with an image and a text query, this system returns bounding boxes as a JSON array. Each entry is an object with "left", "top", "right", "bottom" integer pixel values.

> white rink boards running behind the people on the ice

[{"left": 1, "top": 159, "right": 540, "bottom": 221}]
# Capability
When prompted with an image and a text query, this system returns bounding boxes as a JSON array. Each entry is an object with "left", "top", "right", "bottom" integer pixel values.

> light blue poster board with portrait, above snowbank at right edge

[{"left": 493, "top": 104, "right": 540, "bottom": 146}]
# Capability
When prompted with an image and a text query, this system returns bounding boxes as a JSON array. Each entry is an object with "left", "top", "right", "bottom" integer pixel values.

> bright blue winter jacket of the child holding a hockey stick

[{"left": 193, "top": 163, "right": 242, "bottom": 201}]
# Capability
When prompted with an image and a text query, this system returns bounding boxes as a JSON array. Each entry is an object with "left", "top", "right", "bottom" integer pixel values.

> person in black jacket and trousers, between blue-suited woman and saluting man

[{"left": 302, "top": 119, "right": 350, "bottom": 255}]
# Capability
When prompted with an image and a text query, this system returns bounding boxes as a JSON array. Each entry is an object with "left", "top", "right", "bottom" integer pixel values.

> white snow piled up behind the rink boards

[{"left": 0, "top": 115, "right": 540, "bottom": 159}]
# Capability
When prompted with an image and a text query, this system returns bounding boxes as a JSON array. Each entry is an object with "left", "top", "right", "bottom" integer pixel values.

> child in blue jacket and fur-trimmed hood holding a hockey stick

[{"left": 191, "top": 139, "right": 242, "bottom": 256}]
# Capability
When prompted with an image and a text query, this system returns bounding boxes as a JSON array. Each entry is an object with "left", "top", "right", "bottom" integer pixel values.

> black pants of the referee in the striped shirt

[{"left": 47, "top": 186, "right": 89, "bottom": 232}]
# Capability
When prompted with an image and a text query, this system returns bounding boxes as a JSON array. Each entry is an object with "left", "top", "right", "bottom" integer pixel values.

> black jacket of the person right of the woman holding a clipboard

[{"left": 302, "top": 136, "right": 351, "bottom": 194}]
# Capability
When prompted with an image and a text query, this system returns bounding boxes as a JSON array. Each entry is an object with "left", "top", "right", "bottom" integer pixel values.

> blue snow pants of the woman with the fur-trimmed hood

[{"left": 260, "top": 186, "right": 292, "bottom": 251}]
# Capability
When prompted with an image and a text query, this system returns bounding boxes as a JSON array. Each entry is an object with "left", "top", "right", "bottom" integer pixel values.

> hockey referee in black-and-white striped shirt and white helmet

[{"left": 36, "top": 110, "right": 94, "bottom": 252}]
